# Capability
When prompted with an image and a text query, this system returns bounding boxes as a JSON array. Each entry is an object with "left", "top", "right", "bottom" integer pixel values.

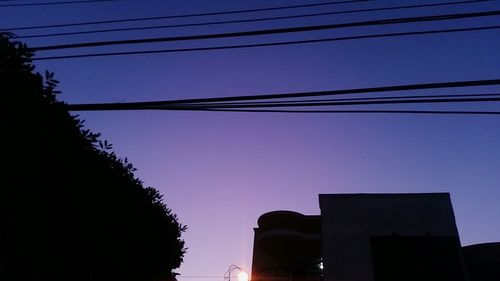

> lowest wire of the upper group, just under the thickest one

[{"left": 32, "top": 25, "right": 500, "bottom": 61}]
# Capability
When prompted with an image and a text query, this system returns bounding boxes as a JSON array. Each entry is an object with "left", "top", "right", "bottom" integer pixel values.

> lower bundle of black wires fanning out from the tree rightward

[{"left": 62, "top": 79, "right": 500, "bottom": 115}]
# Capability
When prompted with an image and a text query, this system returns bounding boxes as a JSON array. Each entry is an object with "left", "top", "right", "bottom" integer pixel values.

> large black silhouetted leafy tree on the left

[{"left": 0, "top": 33, "right": 185, "bottom": 281}]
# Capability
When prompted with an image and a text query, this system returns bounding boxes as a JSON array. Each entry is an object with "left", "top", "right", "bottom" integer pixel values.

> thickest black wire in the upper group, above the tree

[{"left": 30, "top": 10, "right": 500, "bottom": 51}]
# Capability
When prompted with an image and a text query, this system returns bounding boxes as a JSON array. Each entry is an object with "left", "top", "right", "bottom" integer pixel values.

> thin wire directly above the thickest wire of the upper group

[{"left": 16, "top": 0, "right": 492, "bottom": 38}]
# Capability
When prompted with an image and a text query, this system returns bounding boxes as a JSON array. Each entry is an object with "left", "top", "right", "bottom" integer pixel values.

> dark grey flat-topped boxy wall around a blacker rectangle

[{"left": 319, "top": 193, "right": 465, "bottom": 281}]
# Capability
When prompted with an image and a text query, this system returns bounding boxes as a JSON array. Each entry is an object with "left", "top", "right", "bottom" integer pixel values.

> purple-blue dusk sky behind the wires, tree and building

[{"left": 0, "top": 0, "right": 500, "bottom": 280}]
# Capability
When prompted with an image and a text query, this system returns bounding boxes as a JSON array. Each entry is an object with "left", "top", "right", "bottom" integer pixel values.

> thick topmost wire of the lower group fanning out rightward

[{"left": 67, "top": 79, "right": 500, "bottom": 111}]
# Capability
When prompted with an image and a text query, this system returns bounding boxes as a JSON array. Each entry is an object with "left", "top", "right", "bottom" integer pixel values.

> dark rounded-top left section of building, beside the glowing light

[{"left": 252, "top": 211, "right": 322, "bottom": 281}]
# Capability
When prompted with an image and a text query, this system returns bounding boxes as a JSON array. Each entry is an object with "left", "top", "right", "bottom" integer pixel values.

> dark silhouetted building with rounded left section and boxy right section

[{"left": 252, "top": 193, "right": 500, "bottom": 281}]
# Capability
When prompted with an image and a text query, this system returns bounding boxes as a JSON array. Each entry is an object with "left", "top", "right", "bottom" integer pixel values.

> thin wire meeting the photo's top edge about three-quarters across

[{"left": 4, "top": 0, "right": 375, "bottom": 31}]
